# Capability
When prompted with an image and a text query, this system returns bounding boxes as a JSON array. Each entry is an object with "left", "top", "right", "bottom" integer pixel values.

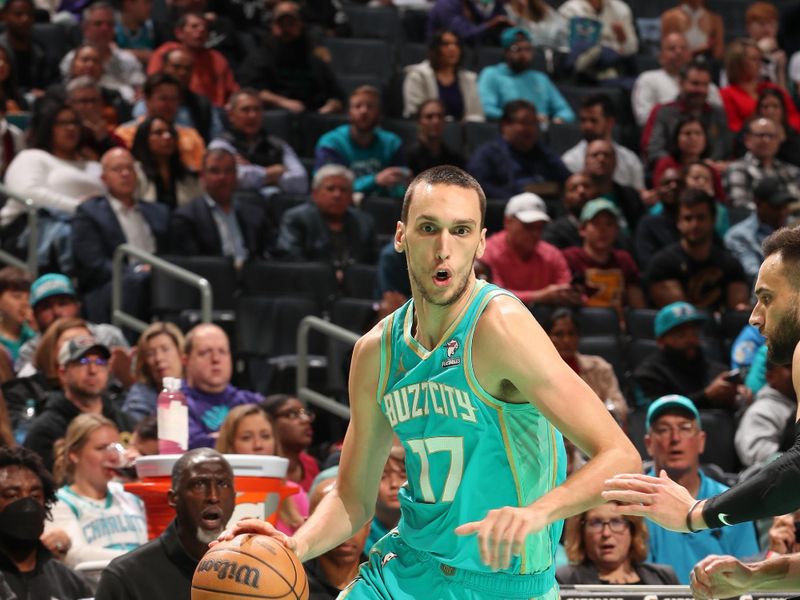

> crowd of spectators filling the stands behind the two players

[{"left": 0, "top": 0, "right": 800, "bottom": 600}]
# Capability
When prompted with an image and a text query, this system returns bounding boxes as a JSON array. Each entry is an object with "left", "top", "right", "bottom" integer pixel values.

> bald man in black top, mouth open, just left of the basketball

[{"left": 95, "top": 448, "right": 236, "bottom": 600}]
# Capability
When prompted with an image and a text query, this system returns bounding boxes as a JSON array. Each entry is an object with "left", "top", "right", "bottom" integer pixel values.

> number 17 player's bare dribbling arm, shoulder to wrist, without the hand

[{"left": 294, "top": 322, "right": 392, "bottom": 561}]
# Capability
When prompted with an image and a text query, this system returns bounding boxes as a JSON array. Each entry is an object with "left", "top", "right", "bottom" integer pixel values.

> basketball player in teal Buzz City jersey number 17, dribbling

[{"left": 216, "top": 166, "right": 641, "bottom": 600}]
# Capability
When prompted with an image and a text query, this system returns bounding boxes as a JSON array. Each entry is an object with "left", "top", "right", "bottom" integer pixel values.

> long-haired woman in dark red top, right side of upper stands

[{"left": 653, "top": 115, "right": 725, "bottom": 199}]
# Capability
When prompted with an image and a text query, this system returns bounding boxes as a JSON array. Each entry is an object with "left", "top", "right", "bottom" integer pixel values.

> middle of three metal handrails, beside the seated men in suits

[{"left": 111, "top": 244, "right": 214, "bottom": 333}]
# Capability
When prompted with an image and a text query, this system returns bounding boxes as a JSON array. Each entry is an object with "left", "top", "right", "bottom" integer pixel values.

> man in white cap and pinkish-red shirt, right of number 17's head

[{"left": 480, "top": 192, "right": 581, "bottom": 306}]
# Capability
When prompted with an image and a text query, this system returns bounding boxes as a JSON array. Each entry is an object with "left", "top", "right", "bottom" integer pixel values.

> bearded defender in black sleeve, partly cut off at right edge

[{"left": 603, "top": 228, "right": 800, "bottom": 598}]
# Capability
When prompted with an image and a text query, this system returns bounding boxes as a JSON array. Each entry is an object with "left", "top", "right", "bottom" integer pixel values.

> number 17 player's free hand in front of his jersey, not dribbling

[{"left": 455, "top": 506, "right": 547, "bottom": 571}]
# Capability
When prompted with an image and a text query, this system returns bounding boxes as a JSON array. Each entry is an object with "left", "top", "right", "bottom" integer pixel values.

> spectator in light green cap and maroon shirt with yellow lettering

[{"left": 562, "top": 198, "right": 645, "bottom": 318}]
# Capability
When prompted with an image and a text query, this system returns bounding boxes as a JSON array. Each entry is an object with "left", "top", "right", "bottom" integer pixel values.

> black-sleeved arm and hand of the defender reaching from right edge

[{"left": 603, "top": 344, "right": 800, "bottom": 531}]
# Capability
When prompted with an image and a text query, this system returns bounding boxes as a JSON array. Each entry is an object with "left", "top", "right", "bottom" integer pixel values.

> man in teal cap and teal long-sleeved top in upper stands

[{"left": 478, "top": 27, "right": 575, "bottom": 123}]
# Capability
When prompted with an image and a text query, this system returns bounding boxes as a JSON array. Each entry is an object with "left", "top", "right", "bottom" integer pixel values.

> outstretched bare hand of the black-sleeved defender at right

[{"left": 603, "top": 470, "right": 700, "bottom": 531}]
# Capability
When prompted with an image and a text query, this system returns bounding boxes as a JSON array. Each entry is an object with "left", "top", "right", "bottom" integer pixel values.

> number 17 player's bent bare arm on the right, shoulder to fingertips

[{"left": 456, "top": 297, "right": 641, "bottom": 568}]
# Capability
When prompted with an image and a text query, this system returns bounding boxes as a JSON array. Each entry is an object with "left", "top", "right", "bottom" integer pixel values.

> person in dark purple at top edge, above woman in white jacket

[{"left": 426, "top": 0, "right": 511, "bottom": 45}]
